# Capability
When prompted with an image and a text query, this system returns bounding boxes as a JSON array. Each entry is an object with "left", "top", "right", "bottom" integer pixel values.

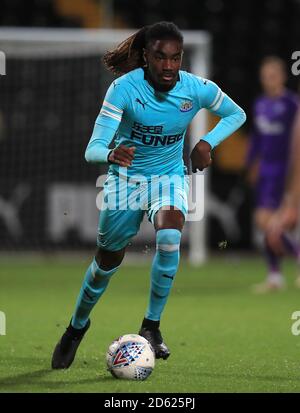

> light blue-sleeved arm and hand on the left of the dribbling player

[{"left": 85, "top": 81, "right": 135, "bottom": 167}]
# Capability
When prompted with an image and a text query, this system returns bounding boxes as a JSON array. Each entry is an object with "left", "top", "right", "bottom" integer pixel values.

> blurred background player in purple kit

[{"left": 246, "top": 56, "right": 299, "bottom": 293}]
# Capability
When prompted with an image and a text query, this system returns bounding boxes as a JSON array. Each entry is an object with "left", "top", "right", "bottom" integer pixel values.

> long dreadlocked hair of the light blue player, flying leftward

[{"left": 103, "top": 21, "right": 183, "bottom": 75}]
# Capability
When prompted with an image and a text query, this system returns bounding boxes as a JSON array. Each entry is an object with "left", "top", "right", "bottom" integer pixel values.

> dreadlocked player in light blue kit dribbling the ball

[{"left": 52, "top": 22, "right": 246, "bottom": 369}]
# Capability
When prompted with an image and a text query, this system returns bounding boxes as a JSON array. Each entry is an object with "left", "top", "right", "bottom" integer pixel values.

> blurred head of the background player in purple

[{"left": 260, "top": 62, "right": 286, "bottom": 95}]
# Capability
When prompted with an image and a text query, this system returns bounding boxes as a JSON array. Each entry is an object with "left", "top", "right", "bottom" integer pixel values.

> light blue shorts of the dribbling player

[{"left": 97, "top": 172, "right": 189, "bottom": 251}]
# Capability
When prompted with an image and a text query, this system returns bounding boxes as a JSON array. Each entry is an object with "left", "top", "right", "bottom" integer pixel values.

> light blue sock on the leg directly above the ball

[{"left": 145, "top": 229, "right": 181, "bottom": 321}]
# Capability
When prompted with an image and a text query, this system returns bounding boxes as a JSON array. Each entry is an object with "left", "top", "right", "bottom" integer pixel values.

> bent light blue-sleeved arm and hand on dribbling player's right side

[{"left": 191, "top": 79, "right": 246, "bottom": 172}]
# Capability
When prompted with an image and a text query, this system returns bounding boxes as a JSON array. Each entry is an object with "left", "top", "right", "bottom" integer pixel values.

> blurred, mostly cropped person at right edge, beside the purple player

[{"left": 267, "top": 110, "right": 300, "bottom": 258}]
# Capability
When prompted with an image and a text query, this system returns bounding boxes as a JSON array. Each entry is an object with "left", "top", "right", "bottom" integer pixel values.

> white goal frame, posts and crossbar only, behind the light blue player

[{"left": 0, "top": 27, "right": 211, "bottom": 265}]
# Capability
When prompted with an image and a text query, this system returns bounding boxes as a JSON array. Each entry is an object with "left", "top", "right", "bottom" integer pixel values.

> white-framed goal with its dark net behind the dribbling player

[{"left": 0, "top": 28, "right": 211, "bottom": 265}]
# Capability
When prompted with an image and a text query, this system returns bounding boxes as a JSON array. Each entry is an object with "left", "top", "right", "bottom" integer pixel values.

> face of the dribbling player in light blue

[{"left": 144, "top": 40, "right": 183, "bottom": 91}]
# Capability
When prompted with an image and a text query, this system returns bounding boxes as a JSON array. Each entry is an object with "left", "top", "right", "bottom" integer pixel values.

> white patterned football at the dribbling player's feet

[{"left": 106, "top": 334, "right": 155, "bottom": 380}]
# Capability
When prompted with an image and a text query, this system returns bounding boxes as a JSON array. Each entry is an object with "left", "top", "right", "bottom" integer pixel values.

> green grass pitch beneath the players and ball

[{"left": 0, "top": 251, "right": 300, "bottom": 393}]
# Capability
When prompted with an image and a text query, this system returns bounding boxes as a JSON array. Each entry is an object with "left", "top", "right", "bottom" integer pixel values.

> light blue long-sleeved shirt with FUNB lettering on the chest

[{"left": 85, "top": 68, "right": 246, "bottom": 177}]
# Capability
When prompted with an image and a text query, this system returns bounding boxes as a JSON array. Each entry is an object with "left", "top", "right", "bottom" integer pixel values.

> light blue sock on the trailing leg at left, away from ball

[{"left": 71, "top": 259, "right": 119, "bottom": 328}]
